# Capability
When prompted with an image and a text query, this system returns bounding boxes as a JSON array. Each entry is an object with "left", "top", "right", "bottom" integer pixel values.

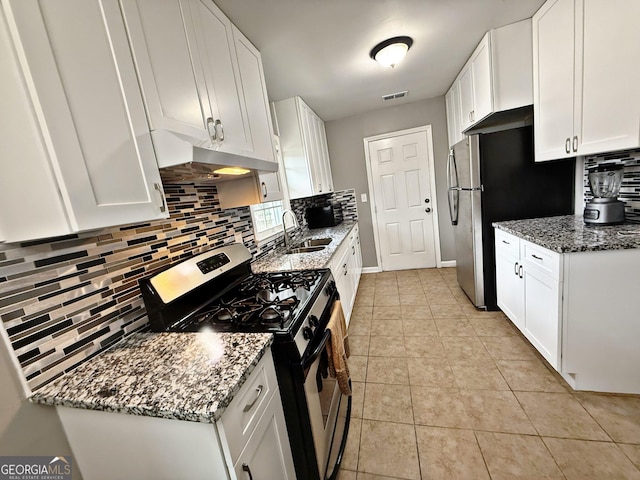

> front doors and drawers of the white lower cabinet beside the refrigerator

[{"left": 495, "top": 230, "right": 561, "bottom": 369}]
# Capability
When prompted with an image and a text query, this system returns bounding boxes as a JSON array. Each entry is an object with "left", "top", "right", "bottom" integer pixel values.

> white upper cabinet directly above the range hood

[{"left": 121, "top": 0, "right": 274, "bottom": 166}]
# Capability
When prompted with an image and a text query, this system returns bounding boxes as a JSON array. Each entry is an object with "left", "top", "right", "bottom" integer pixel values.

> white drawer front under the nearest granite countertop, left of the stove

[{"left": 218, "top": 352, "right": 278, "bottom": 462}]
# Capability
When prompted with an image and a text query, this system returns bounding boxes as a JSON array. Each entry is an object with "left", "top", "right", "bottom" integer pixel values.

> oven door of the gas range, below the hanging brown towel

[{"left": 304, "top": 330, "right": 351, "bottom": 479}]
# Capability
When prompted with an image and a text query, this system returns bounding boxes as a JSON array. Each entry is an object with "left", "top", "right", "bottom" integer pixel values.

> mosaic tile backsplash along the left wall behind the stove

[{"left": 0, "top": 183, "right": 355, "bottom": 390}]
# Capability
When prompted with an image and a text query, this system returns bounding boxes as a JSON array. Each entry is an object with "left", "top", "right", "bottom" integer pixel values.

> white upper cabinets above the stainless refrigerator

[{"left": 445, "top": 19, "right": 533, "bottom": 145}]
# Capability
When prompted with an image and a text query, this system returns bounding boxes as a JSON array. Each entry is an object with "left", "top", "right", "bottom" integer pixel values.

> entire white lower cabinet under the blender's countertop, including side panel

[{"left": 495, "top": 230, "right": 640, "bottom": 394}]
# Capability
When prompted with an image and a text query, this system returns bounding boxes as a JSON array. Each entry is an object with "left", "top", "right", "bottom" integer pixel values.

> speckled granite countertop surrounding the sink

[{"left": 251, "top": 222, "right": 357, "bottom": 273}]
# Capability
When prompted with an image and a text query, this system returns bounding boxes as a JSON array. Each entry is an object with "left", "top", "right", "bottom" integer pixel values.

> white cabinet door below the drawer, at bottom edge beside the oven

[{"left": 234, "top": 392, "right": 296, "bottom": 480}]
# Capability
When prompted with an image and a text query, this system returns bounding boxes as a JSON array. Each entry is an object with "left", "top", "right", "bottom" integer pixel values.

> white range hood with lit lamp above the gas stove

[{"left": 151, "top": 130, "right": 278, "bottom": 183}]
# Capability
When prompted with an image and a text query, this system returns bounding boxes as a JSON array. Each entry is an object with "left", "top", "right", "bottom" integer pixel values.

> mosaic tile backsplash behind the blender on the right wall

[{"left": 584, "top": 150, "right": 640, "bottom": 223}]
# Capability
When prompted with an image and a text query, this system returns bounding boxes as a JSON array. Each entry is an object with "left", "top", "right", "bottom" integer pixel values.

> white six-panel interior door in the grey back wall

[{"left": 365, "top": 126, "right": 438, "bottom": 270}]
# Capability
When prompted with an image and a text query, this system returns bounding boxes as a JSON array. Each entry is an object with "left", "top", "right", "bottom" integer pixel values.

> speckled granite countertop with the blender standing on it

[{"left": 493, "top": 215, "right": 640, "bottom": 253}]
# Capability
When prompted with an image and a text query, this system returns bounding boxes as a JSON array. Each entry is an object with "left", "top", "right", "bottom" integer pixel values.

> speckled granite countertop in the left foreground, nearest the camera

[{"left": 31, "top": 332, "right": 273, "bottom": 423}]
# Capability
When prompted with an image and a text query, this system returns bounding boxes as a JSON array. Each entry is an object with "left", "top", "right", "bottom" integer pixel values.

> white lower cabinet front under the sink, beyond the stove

[{"left": 330, "top": 225, "right": 362, "bottom": 325}]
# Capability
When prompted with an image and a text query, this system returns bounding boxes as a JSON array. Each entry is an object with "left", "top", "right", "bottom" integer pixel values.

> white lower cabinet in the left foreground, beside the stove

[{"left": 56, "top": 352, "right": 295, "bottom": 480}]
